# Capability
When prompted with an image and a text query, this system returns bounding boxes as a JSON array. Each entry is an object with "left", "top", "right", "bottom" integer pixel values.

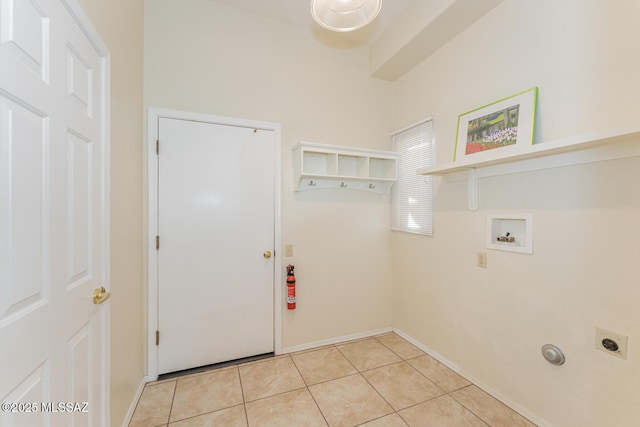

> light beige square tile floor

[{"left": 129, "top": 333, "right": 534, "bottom": 427}]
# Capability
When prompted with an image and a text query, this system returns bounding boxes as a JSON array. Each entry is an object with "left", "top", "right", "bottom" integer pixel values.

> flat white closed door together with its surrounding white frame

[{"left": 148, "top": 109, "right": 284, "bottom": 380}]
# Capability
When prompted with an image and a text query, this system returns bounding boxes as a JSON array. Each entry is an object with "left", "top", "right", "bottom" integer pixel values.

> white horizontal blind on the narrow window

[{"left": 391, "top": 120, "right": 433, "bottom": 235}]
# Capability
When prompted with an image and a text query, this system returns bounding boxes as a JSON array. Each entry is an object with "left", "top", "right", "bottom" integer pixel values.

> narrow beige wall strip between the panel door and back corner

[{"left": 74, "top": 0, "right": 144, "bottom": 426}]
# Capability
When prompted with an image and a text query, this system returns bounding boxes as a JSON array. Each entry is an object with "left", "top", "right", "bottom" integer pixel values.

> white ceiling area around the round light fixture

[{"left": 211, "top": 0, "right": 424, "bottom": 44}]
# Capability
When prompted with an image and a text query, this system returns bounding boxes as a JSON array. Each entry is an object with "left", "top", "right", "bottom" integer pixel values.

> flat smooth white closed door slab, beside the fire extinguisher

[{"left": 158, "top": 118, "right": 275, "bottom": 374}]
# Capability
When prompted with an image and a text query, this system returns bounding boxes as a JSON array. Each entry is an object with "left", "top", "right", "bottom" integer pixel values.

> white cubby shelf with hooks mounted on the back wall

[{"left": 292, "top": 142, "right": 398, "bottom": 194}]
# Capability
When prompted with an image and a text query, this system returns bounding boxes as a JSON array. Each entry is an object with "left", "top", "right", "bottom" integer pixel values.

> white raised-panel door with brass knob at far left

[{"left": 0, "top": 0, "right": 109, "bottom": 427}]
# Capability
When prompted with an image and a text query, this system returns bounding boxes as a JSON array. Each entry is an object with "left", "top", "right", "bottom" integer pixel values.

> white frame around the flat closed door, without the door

[{"left": 145, "top": 107, "right": 284, "bottom": 381}]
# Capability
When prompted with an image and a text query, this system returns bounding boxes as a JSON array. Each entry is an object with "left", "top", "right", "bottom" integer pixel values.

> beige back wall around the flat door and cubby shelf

[{"left": 145, "top": 0, "right": 392, "bottom": 349}]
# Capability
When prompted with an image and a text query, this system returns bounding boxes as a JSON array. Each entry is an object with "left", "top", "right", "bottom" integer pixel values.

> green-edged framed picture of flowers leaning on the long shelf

[{"left": 453, "top": 87, "right": 538, "bottom": 161}]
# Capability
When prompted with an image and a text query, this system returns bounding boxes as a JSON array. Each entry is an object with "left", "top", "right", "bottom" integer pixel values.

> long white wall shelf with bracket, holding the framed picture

[{"left": 416, "top": 127, "right": 640, "bottom": 210}]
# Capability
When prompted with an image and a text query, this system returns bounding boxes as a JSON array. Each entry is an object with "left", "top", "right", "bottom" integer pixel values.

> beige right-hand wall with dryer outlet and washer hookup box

[{"left": 392, "top": 0, "right": 640, "bottom": 427}]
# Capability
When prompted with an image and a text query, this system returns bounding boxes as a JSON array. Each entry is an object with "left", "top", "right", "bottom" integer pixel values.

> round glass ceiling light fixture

[{"left": 311, "top": 0, "right": 382, "bottom": 32}]
